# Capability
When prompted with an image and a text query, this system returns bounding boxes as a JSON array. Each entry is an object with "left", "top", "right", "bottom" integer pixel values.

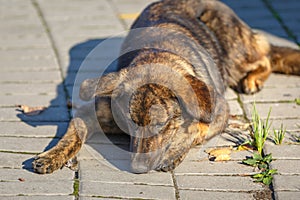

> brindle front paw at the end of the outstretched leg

[{"left": 32, "top": 153, "right": 64, "bottom": 174}]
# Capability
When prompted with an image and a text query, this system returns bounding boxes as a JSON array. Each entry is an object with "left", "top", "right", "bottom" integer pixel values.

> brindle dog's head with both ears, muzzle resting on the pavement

[{"left": 80, "top": 58, "right": 214, "bottom": 173}]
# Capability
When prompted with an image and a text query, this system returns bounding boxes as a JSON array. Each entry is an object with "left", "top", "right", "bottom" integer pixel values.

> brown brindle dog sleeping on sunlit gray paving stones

[{"left": 33, "top": 0, "right": 300, "bottom": 173}]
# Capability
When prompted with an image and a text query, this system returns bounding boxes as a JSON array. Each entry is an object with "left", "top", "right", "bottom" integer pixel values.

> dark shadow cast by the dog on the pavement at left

[{"left": 17, "top": 37, "right": 134, "bottom": 172}]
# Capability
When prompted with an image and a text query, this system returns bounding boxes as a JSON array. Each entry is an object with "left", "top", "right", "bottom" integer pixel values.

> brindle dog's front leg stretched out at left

[{"left": 32, "top": 98, "right": 121, "bottom": 174}]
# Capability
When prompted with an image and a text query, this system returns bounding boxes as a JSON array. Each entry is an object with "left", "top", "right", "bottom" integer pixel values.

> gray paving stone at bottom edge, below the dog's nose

[{"left": 80, "top": 181, "right": 175, "bottom": 199}]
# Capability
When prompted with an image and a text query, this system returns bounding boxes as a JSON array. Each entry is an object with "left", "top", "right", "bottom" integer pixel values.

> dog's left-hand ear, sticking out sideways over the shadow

[{"left": 79, "top": 72, "right": 120, "bottom": 101}]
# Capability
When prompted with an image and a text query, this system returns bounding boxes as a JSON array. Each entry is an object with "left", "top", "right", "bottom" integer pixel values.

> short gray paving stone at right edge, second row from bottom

[{"left": 273, "top": 175, "right": 300, "bottom": 192}]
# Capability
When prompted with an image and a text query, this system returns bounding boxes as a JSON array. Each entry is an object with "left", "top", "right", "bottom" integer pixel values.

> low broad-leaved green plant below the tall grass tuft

[{"left": 242, "top": 153, "right": 277, "bottom": 185}]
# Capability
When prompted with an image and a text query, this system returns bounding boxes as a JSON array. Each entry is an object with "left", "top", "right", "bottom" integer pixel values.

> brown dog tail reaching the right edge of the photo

[{"left": 270, "top": 45, "right": 300, "bottom": 75}]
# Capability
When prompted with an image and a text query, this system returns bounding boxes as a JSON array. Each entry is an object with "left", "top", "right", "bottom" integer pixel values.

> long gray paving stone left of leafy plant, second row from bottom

[{"left": 176, "top": 175, "right": 264, "bottom": 192}]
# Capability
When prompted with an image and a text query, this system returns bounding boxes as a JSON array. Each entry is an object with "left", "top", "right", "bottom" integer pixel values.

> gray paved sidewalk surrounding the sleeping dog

[{"left": 0, "top": 0, "right": 300, "bottom": 200}]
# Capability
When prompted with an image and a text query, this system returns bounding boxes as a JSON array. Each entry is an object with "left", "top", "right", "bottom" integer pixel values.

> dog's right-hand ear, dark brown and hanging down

[{"left": 178, "top": 75, "right": 215, "bottom": 123}]
